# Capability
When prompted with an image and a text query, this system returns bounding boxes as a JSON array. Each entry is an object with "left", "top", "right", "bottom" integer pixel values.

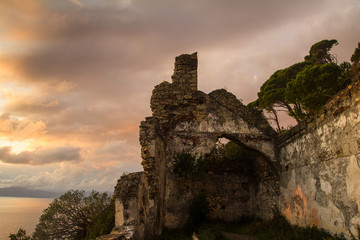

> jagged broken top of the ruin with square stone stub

[{"left": 150, "top": 53, "right": 276, "bottom": 137}]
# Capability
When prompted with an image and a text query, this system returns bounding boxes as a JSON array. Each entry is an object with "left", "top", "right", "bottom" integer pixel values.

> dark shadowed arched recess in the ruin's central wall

[{"left": 192, "top": 136, "right": 276, "bottom": 221}]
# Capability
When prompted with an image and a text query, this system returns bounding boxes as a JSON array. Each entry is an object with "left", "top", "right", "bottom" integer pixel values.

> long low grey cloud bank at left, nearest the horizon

[{"left": 0, "top": 147, "right": 81, "bottom": 165}]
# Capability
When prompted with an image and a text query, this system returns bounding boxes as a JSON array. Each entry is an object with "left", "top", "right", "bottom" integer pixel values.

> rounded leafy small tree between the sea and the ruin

[{"left": 33, "top": 190, "right": 110, "bottom": 240}]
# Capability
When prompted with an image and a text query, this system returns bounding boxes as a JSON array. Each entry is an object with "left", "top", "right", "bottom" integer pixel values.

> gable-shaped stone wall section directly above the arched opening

[{"left": 169, "top": 89, "right": 278, "bottom": 164}]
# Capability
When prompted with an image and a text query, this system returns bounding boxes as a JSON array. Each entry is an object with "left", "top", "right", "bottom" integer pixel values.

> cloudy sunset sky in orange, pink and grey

[{"left": 0, "top": 0, "right": 360, "bottom": 191}]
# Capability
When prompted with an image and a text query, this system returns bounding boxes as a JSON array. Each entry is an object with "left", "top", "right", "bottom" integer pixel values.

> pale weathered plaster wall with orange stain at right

[{"left": 278, "top": 83, "right": 360, "bottom": 236}]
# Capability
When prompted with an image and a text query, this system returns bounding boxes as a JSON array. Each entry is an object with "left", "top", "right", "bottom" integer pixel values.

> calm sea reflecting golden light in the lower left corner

[{"left": 0, "top": 197, "right": 53, "bottom": 240}]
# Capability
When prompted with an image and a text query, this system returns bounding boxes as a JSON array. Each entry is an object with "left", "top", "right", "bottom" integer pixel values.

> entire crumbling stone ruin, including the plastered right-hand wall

[{"left": 111, "top": 53, "right": 360, "bottom": 240}]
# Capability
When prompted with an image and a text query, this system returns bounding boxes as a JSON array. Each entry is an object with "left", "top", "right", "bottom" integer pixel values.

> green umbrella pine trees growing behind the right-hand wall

[{"left": 248, "top": 39, "right": 360, "bottom": 132}]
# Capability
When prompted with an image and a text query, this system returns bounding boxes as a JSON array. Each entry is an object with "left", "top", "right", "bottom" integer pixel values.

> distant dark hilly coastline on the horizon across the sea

[{"left": 0, "top": 187, "right": 61, "bottom": 198}]
